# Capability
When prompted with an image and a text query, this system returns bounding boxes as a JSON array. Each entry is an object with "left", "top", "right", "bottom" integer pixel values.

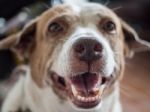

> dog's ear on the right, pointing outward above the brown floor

[{"left": 121, "top": 20, "right": 150, "bottom": 57}]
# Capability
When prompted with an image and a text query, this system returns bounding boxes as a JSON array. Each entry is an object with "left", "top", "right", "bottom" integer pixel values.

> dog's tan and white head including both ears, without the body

[{"left": 0, "top": 4, "right": 149, "bottom": 109}]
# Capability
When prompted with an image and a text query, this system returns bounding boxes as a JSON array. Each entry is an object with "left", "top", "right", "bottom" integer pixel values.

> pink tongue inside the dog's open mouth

[{"left": 71, "top": 73, "right": 101, "bottom": 93}]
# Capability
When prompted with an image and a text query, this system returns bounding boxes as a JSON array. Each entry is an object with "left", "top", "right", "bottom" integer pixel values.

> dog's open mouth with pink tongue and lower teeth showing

[{"left": 51, "top": 72, "right": 111, "bottom": 109}]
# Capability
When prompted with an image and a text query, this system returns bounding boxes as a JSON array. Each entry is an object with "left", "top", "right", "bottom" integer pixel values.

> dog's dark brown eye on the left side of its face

[{"left": 48, "top": 22, "right": 63, "bottom": 33}]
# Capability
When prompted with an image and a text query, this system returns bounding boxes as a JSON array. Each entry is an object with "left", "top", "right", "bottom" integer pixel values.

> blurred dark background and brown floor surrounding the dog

[{"left": 0, "top": 0, "right": 150, "bottom": 112}]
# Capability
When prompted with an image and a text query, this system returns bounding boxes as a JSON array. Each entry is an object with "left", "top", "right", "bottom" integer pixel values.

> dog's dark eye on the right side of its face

[{"left": 102, "top": 21, "right": 116, "bottom": 33}]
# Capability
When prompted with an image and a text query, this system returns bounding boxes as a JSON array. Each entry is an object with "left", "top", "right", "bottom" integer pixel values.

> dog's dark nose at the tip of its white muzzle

[{"left": 74, "top": 38, "right": 103, "bottom": 63}]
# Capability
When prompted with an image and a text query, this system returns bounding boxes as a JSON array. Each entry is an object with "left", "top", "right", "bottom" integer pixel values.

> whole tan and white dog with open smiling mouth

[{"left": 0, "top": 2, "right": 150, "bottom": 112}]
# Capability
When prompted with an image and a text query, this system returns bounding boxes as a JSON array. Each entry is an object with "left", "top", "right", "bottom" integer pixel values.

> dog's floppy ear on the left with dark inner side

[{"left": 0, "top": 19, "right": 38, "bottom": 59}]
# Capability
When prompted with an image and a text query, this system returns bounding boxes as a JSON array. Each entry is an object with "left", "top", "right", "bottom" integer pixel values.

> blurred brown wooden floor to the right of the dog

[{"left": 121, "top": 52, "right": 150, "bottom": 112}]
